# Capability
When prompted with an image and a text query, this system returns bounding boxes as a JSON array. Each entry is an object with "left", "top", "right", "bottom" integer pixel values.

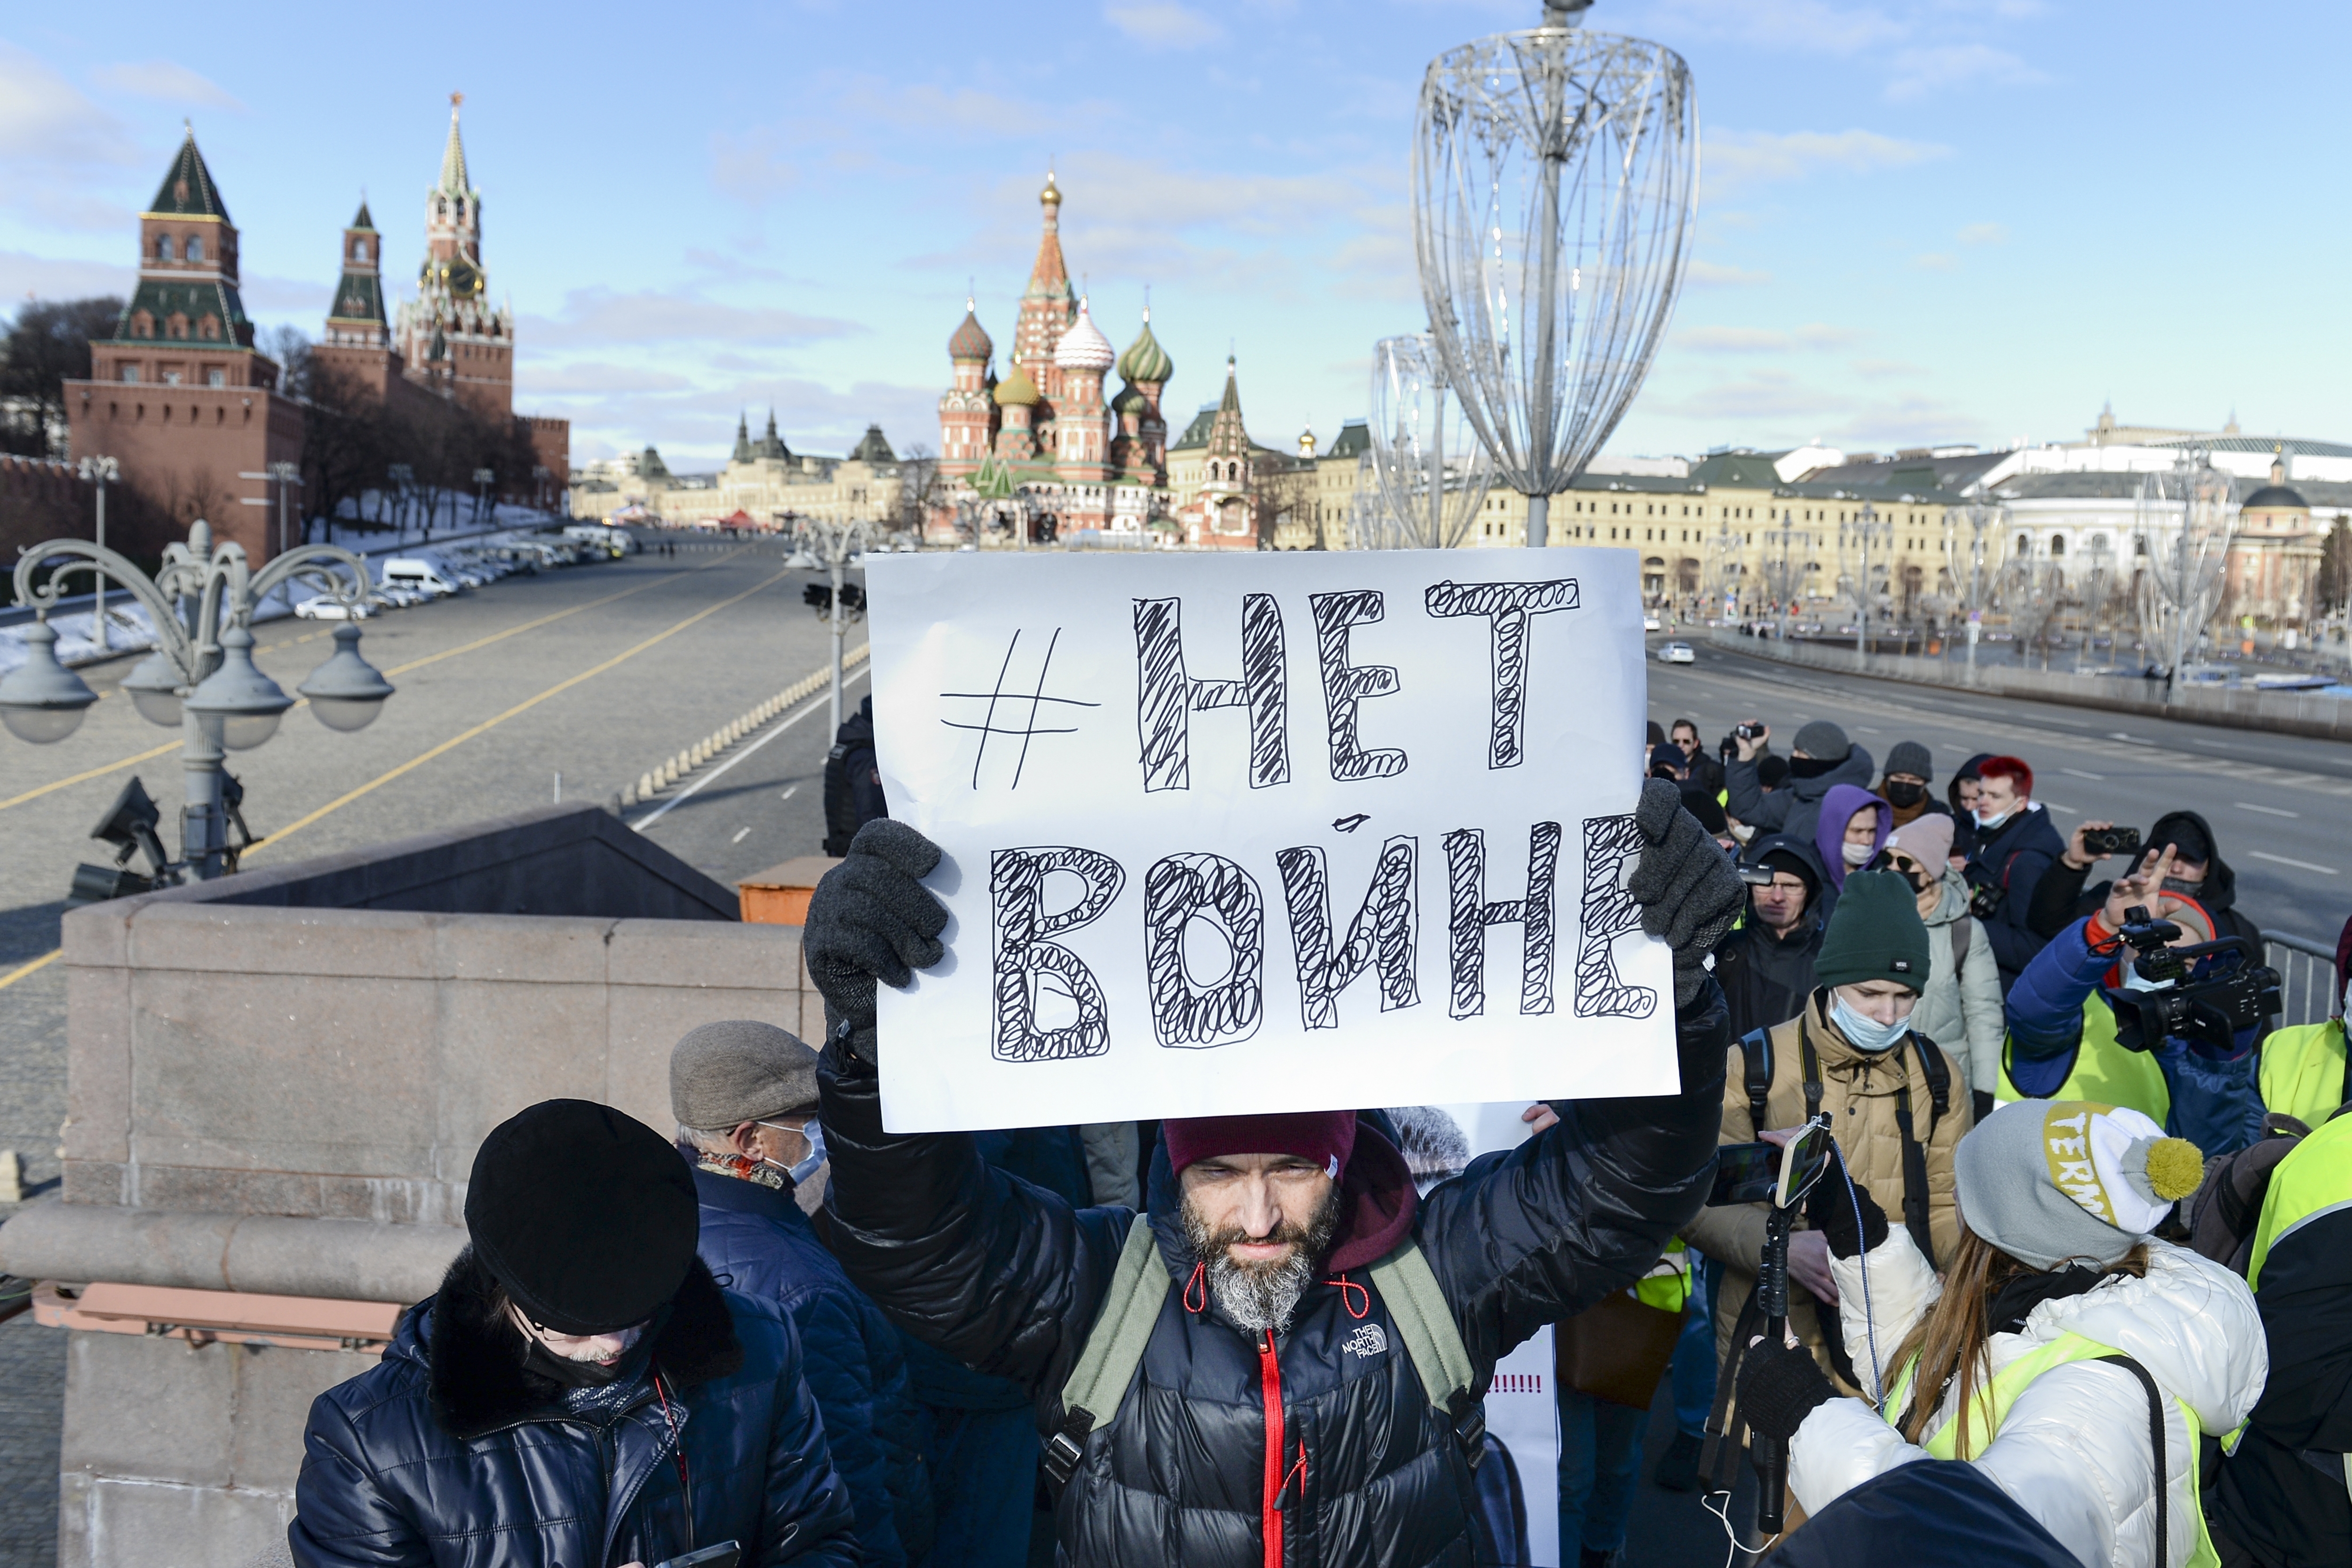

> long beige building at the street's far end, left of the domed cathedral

[{"left": 572, "top": 414, "right": 906, "bottom": 529}]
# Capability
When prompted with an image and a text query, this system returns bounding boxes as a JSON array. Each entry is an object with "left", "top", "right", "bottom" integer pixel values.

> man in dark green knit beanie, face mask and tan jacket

[{"left": 1684, "top": 872, "right": 1973, "bottom": 1448}]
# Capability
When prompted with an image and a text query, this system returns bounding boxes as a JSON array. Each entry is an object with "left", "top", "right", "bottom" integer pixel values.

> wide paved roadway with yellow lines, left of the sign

[{"left": 0, "top": 541, "right": 863, "bottom": 1563}]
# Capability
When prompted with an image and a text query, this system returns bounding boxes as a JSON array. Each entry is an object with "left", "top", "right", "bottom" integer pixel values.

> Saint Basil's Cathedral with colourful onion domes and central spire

[{"left": 938, "top": 174, "right": 1176, "bottom": 539}]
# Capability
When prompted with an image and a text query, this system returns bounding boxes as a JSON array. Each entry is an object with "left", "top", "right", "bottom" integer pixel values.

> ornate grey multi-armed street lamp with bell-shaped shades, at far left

[{"left": 0, "top": 520, "right": 393, "bottom": 881}]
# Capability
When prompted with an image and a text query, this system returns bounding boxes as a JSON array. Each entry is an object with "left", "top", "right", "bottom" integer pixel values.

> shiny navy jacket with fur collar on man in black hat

[{"left": 287, "top": 1251, "right": 858, "bottom": 1568}]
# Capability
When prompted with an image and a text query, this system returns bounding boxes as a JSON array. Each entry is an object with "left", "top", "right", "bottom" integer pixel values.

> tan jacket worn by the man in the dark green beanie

[{"left": 1684, "top": 990, "right": 1971, "bottom": 1392}]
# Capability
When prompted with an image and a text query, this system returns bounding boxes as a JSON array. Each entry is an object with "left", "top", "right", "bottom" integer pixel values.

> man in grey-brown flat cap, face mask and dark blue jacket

[{"left": 670, "top": 1020, "right": 934, "bottom": 1566}]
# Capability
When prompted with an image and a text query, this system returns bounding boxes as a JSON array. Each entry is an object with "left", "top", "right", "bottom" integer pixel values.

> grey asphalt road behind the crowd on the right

[{"left": 1649, "top": 640, "right": 2352, "bottom": 947}]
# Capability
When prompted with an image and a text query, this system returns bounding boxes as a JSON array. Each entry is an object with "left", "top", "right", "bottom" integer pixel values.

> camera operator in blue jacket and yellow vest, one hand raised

[{"left": 1997, "top": 846, "right": 2263, "bottom": 1159}]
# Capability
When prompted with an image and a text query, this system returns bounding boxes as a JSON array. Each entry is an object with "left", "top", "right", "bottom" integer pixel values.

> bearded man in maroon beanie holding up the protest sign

[{"left": 804, "top": 781, "right": 1743, "bottom": 1568}]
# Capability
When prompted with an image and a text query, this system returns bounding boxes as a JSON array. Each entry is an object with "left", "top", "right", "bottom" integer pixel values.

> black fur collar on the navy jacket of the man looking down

[{"left": 405, "top": 1246, "right": 743, "bottom": 1439}]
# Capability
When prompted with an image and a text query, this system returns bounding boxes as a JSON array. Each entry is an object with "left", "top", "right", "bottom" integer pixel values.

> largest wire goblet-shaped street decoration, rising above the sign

[{"left": 1414, "top": 0, "right": 1698, "bottom": 548}]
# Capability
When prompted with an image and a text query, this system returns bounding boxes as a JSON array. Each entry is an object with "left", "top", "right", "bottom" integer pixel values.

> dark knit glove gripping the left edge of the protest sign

[{"left": 800, "top": 818, "right": 948, "bottom": 1062}]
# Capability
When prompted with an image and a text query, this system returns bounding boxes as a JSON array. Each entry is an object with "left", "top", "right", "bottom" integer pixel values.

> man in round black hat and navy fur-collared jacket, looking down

[{"left": 287, "top": 1100, "right": 861, "bottom": 1568}]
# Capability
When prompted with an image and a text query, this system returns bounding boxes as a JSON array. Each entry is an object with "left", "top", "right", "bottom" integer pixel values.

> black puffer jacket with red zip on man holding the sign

[{"left": 818, "top": 985, "right": 1729, "bottom": 1568}]
